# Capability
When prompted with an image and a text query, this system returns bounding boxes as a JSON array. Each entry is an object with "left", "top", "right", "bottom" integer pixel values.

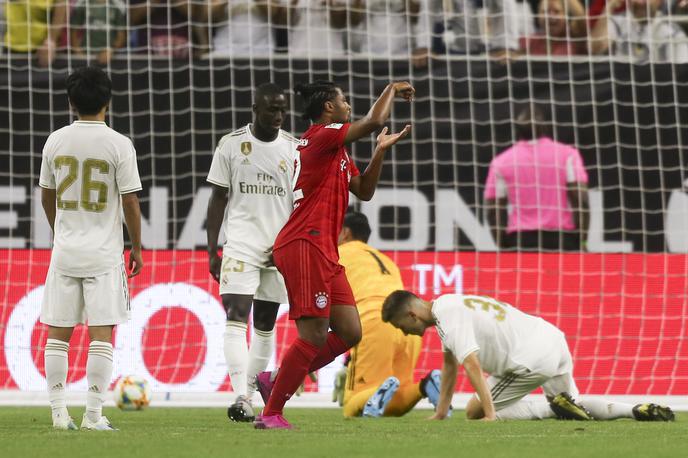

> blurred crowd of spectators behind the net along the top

[{"left": 0, "top": 0, "right": 688, "bottom": 67}]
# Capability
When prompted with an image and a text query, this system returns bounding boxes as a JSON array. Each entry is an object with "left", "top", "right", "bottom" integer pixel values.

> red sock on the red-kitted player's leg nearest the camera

[{"left": 263, "top": 338, "right": 319, "bottom": 416}]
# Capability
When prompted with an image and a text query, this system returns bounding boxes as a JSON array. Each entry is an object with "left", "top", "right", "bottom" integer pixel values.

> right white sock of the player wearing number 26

[{"left": 86, "top": 340, "right": 112, "bottom": 423}]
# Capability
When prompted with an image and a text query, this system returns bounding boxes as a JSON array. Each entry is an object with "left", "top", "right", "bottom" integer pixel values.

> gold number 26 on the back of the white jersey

[{"left": 55, "top": 156, "right": 110, "bottom": 213}]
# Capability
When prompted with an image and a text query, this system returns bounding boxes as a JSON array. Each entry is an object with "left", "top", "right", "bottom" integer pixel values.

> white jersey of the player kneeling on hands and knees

[{"left": 432, "top": 294, "right": 572, "bottom": 376}]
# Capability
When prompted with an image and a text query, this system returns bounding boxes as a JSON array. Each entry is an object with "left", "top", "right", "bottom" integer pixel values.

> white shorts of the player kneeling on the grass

[{"left": 487, "top": 339, "right": 579, "bottom": 410}]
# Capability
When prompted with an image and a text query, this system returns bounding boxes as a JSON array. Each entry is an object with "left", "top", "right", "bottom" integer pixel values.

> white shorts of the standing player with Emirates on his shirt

[{"left": 220, "top": 256, "right": 287, "bottom": 304}]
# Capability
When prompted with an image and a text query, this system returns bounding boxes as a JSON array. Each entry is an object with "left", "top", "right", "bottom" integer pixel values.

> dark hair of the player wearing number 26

[{"left": 65, "top": 67, "right": 112, "bottom": 115}]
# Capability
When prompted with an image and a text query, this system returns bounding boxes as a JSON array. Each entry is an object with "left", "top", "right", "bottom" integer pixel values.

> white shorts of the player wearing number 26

[{"left": 41, "top": 264, "right": 130, "bottom": 328}]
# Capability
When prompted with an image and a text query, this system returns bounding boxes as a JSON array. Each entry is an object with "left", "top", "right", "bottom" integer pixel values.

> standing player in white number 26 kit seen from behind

[{"left": 39, "top": 67, "right": 143, "bottom": 431}]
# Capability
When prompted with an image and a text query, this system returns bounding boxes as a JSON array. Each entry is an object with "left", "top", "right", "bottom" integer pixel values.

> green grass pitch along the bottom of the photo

[{"left": 0, "top": 407, "right": 688, "bottom": 458}]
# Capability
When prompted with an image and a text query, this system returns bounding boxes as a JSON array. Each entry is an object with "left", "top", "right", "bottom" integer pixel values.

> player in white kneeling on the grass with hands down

[{"left": 382, "top": 290, "right": 674, "bottom": 421}]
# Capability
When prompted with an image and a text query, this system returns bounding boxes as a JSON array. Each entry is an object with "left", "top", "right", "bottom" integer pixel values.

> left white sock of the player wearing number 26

[{"left": 45, "top": 339, "right": 69, "bottom": 420}]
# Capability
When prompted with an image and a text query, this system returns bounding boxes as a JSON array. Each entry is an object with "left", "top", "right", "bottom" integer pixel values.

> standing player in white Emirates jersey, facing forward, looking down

[{"left": 206, "top": 83, "right": 298, "bottom": 422}]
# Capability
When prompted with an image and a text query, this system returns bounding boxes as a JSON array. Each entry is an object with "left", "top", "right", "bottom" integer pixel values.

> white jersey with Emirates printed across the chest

[{"left": 208, "top": 124, "right": 298, "bottom": 267}]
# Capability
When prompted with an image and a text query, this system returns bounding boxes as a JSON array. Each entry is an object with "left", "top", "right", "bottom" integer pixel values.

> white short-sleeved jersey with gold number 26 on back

[{"left": 39, "top": 121, "right": 141, "bottom": 277}]
